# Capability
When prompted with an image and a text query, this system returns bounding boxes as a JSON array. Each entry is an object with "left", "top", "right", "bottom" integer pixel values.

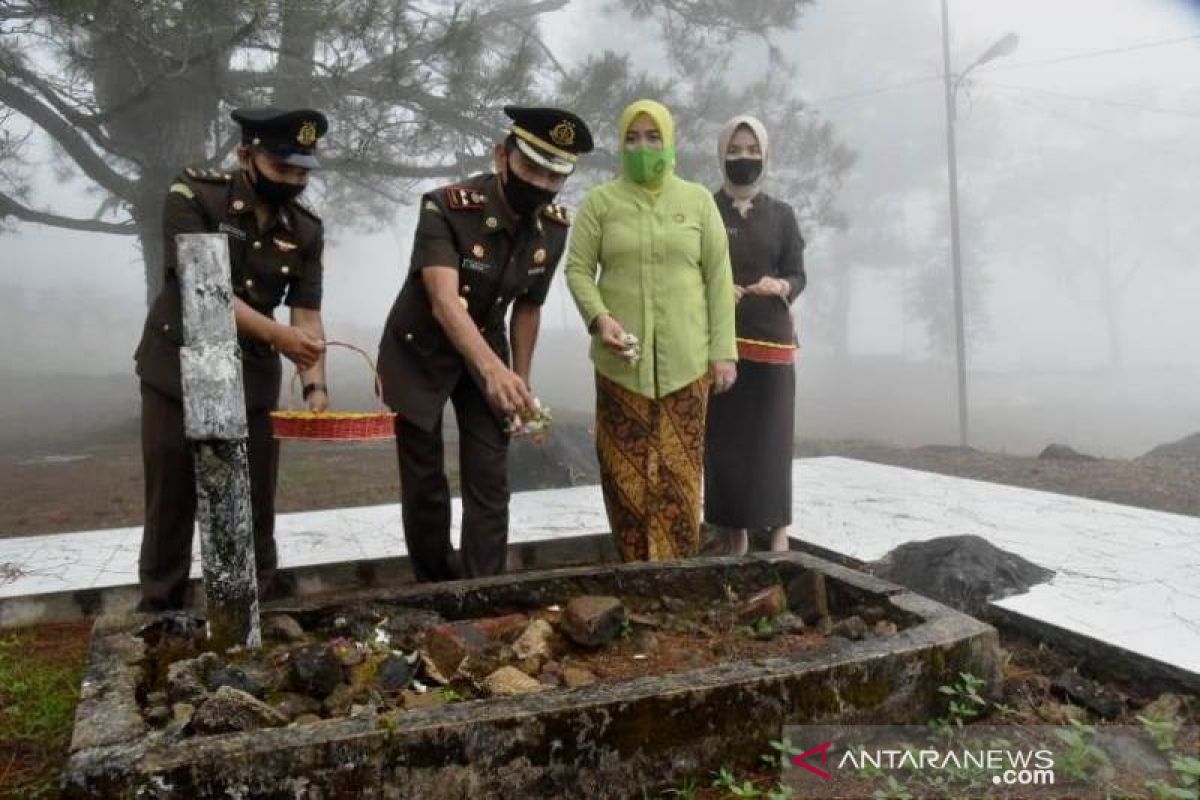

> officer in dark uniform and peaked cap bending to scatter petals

[{"left": 379, "top": 106, "right": 592, "bottom": 581}]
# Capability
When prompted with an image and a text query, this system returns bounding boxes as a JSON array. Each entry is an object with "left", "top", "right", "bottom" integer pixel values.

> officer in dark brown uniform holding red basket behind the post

[{"left": 134, "top": 108, "right": 329, "bottom": 612}]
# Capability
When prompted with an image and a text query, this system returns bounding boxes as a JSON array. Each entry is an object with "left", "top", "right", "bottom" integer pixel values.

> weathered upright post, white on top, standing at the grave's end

[{"left": 175, "top": 234, "right": 262, "bottom": 650}]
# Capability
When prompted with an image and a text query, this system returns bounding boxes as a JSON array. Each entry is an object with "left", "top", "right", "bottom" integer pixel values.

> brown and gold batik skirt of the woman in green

[{"left": 596, "top": 374, "right": 712, "bottom": 561}]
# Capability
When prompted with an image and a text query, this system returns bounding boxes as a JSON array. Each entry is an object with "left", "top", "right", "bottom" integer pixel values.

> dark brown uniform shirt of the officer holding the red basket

[{"left": 133, "top": 169, "right": 324, "bottom": 410}]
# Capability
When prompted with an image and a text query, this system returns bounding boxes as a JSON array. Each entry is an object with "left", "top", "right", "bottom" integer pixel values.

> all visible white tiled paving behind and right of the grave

[{"left": 0, "top": 458, "right": 1200, "bottom": 673}]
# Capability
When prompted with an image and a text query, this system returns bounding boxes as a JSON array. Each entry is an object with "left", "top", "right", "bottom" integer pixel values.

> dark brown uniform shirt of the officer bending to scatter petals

[{"left": 379, "top": 174, "right": 569, "bottom": 429}]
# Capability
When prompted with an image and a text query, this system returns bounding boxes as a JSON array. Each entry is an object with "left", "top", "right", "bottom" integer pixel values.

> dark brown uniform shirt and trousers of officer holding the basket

[{"left": 134, "top": 169, "right": 323, "bottom": 612}]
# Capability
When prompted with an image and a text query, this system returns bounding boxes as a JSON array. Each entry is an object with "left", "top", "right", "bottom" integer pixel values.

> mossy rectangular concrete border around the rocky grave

[{"left": 64, "top": 552, "right": 1001, "bottom": 800}]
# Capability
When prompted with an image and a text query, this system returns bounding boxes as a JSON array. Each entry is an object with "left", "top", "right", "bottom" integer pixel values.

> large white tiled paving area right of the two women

[{"left": 792, "top": 458, "right": 1200, "bottom": 673}]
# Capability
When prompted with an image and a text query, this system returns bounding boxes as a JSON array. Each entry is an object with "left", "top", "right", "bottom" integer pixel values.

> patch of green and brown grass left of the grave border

[{"left": 0, "top": 622, "right": 91, "bottom": 800}]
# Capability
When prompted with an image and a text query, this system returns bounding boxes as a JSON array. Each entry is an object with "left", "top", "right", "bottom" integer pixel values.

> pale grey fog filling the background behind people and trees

[{"left": 0, "top": 0, "right": 1200, "bottom": 456}]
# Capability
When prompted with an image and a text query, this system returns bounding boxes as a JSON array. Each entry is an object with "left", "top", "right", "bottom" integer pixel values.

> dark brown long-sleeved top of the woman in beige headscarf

[{"left": 714, "top": 190, "right": 808, "bottom": 344}]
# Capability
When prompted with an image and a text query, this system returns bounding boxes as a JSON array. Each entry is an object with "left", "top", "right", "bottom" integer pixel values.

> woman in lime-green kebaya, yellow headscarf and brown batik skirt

[{"left": 565, "top": 100, "right": 737, "bottom": 561}]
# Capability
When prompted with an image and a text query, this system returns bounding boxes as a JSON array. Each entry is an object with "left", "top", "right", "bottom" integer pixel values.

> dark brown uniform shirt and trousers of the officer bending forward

[{"left": 379, "top": 174, "right": 568, "bottom": 581}]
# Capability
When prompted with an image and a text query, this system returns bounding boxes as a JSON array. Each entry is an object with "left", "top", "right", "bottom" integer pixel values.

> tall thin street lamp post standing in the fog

[{"left": 942, "top": 0, "right": 1020, "bottom": 447}]
